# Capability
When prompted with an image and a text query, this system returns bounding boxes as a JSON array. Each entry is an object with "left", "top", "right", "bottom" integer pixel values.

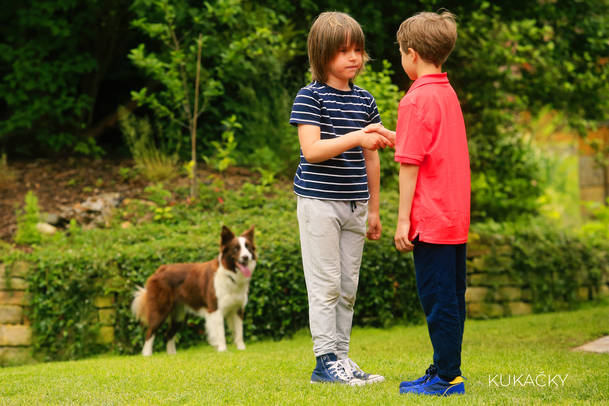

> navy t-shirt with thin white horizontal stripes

[{"left": 290, "top": 81, "right": 381, "bottom": 200}]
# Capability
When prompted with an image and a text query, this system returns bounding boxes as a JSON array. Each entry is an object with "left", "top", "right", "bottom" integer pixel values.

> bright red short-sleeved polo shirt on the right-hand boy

[{"left": 395, "top": 73, "right": 471, "bottom": 244}]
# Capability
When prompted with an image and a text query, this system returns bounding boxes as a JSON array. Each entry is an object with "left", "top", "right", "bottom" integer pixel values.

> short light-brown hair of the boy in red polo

[{"left": 397, "top": 11, "right": 457, "bottom": 67}]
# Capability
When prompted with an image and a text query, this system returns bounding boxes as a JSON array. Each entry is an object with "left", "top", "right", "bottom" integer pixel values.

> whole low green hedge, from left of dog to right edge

[{"left": 3, "top": 185, "right": 608, "bottom": 360}]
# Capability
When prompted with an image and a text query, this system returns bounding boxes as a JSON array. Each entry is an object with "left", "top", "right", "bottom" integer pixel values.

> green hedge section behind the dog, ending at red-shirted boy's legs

[{"left": 15, "top": 186, "right": 421, "bottom": 360}]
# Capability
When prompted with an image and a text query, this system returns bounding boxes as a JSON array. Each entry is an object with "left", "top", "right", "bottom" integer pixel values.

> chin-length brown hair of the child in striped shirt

[{"left": 307, "top": 11, "right": 370, "bottom": 83}]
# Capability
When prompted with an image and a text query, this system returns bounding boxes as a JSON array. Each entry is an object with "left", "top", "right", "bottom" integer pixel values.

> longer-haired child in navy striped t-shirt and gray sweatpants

[{"left": 290, "top": 12, "right": 393, "bottom": 386}]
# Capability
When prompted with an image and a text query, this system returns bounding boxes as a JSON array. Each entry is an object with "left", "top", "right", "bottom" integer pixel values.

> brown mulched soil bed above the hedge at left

[{"left": 0, "top": 159, "right": 258, "bottom": 250}]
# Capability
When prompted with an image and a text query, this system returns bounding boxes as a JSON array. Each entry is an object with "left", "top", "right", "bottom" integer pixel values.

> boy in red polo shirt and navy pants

[{"left": 367, "top": 12, "right": 470, "bottom": 395}]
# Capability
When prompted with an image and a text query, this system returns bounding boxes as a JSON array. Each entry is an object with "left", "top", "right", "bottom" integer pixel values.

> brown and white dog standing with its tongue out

[{"left": 131, "top": 225, "right": 257, "bottom": 356}]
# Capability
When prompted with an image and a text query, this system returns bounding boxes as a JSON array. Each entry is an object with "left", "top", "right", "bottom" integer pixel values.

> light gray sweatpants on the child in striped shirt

[{"left": 297, "top": 196, "right": 368, "bottom": 359}]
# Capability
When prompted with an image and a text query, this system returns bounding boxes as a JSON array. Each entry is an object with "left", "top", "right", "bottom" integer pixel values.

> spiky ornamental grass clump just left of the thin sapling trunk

[{"left": 118, "top": 107, "right": 178, "bottom": 182}]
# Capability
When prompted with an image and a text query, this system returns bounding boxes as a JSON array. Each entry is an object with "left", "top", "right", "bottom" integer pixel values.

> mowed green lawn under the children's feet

[{"left": 0, "top": 304, "right": 609, "bottom": 405}]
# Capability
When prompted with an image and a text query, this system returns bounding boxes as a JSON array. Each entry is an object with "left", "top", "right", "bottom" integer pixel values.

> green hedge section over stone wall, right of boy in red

[{"left": 473, "top": 219, "right": 609, "bottom": 312}]
